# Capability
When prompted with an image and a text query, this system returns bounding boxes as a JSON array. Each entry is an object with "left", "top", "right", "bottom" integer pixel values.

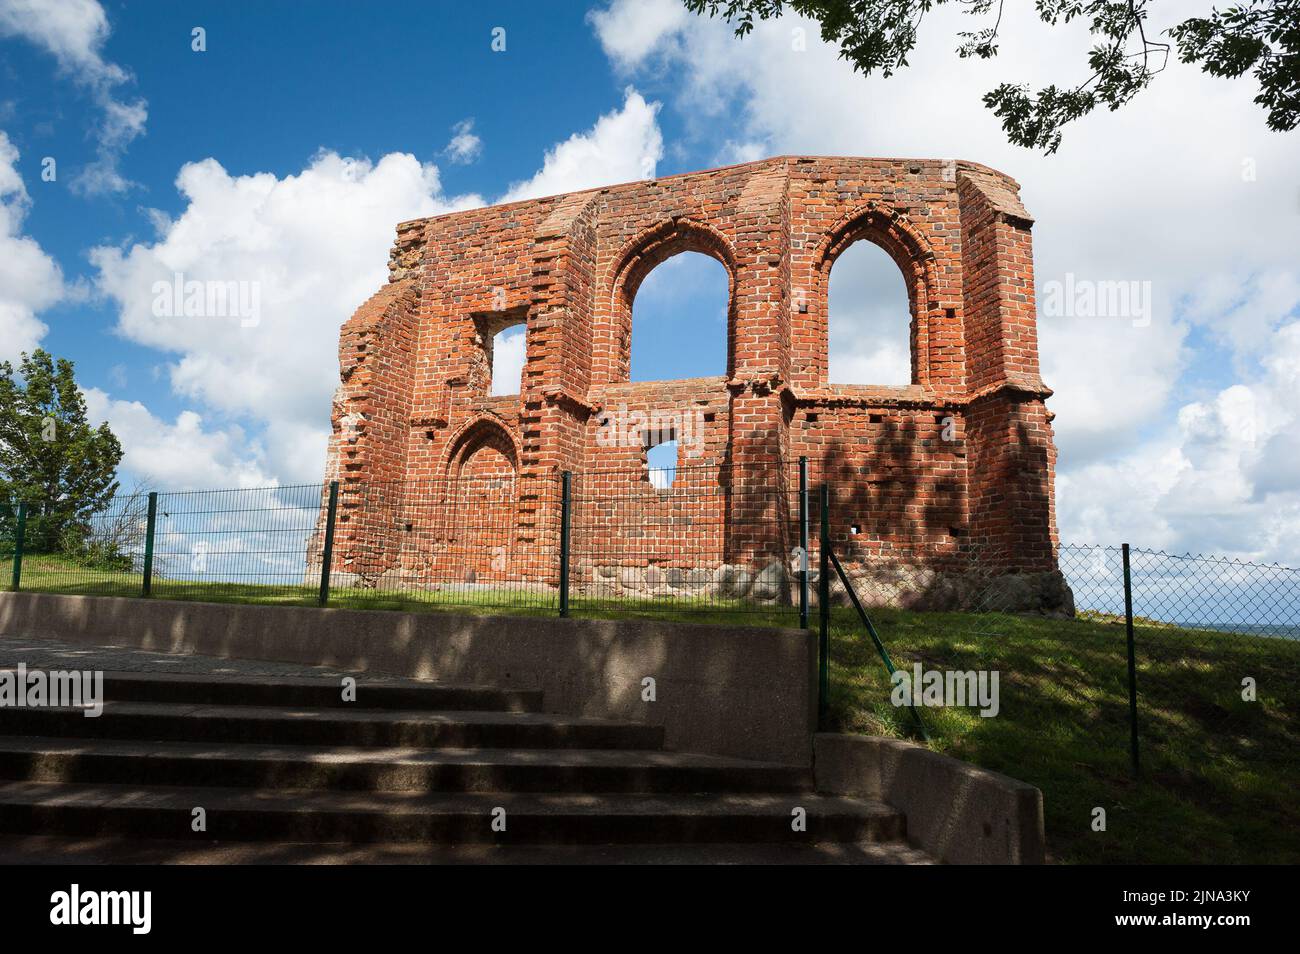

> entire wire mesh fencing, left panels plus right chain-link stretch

[{"left": 0, "top": 461, "right": 1300, "bottom": 852}]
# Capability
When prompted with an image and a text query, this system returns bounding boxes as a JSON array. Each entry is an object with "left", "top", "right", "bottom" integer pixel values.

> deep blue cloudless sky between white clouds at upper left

[{"left": 0, "top": 1, "right": 637, "bottom": 416}]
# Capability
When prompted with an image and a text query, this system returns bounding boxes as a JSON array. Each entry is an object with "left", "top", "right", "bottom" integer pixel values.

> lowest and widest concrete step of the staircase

[{"left": 0, "top": 781, "right": 906, "bottom": 845}]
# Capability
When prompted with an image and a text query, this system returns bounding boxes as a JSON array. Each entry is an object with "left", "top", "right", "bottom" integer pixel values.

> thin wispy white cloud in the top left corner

[{"left": 0, "top": 0, "right": 148, "bottom": 195}]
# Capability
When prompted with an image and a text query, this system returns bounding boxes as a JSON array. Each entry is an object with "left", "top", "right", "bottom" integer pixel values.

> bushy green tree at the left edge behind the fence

[{"left": 0, "top": 348, "right": 122, "bottom": 551}]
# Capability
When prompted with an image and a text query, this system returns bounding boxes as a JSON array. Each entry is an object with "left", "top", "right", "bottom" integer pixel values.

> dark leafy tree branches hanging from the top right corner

[{"left": 684, "top": 0, "right": 1300, "bottom": 153}]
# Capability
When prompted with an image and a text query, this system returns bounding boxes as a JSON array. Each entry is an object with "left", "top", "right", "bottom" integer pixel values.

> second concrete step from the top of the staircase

[{"left": 0, "top": 702, "right": 663, "bottom": 749}]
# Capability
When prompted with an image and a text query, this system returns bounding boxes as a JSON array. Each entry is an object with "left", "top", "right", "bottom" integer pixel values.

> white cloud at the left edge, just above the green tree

[{"left": 0, "top": 130, "right": 64, "bottom": 361}]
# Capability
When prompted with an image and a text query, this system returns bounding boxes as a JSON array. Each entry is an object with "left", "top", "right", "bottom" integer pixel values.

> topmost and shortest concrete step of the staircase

[{"left": 7, "top": 667, "right": 542, "bottom": 712}]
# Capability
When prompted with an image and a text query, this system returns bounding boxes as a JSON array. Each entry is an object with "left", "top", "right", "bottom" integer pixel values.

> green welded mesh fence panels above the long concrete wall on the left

[{"left": 0, "top": 461, "right": 821, "bottom": 625}]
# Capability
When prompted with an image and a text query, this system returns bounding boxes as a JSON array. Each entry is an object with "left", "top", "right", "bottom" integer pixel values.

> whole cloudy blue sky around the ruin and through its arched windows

[{"left": 0, "top": 0, "right": 1300, "bottom": 564}]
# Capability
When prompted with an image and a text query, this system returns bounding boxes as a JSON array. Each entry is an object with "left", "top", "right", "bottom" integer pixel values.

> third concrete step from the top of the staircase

[{"left": 0, "top": 738, "right": 813, "bottom": 793}]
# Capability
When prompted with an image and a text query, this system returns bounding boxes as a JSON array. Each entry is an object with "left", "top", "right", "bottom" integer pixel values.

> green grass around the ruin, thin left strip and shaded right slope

[{"left": 5, "top": 555, "right": 1300, "bottom": 864}]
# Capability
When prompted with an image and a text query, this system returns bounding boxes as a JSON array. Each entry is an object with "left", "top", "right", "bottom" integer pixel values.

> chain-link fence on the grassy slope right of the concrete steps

[{"left": 831, "top": 545, "right": 1300, "bottom": 772}]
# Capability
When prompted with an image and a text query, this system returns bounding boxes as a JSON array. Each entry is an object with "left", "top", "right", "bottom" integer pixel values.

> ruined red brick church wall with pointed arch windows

[{"left": 328, "top": 156, "right": 1065, "bottom": 603}]
